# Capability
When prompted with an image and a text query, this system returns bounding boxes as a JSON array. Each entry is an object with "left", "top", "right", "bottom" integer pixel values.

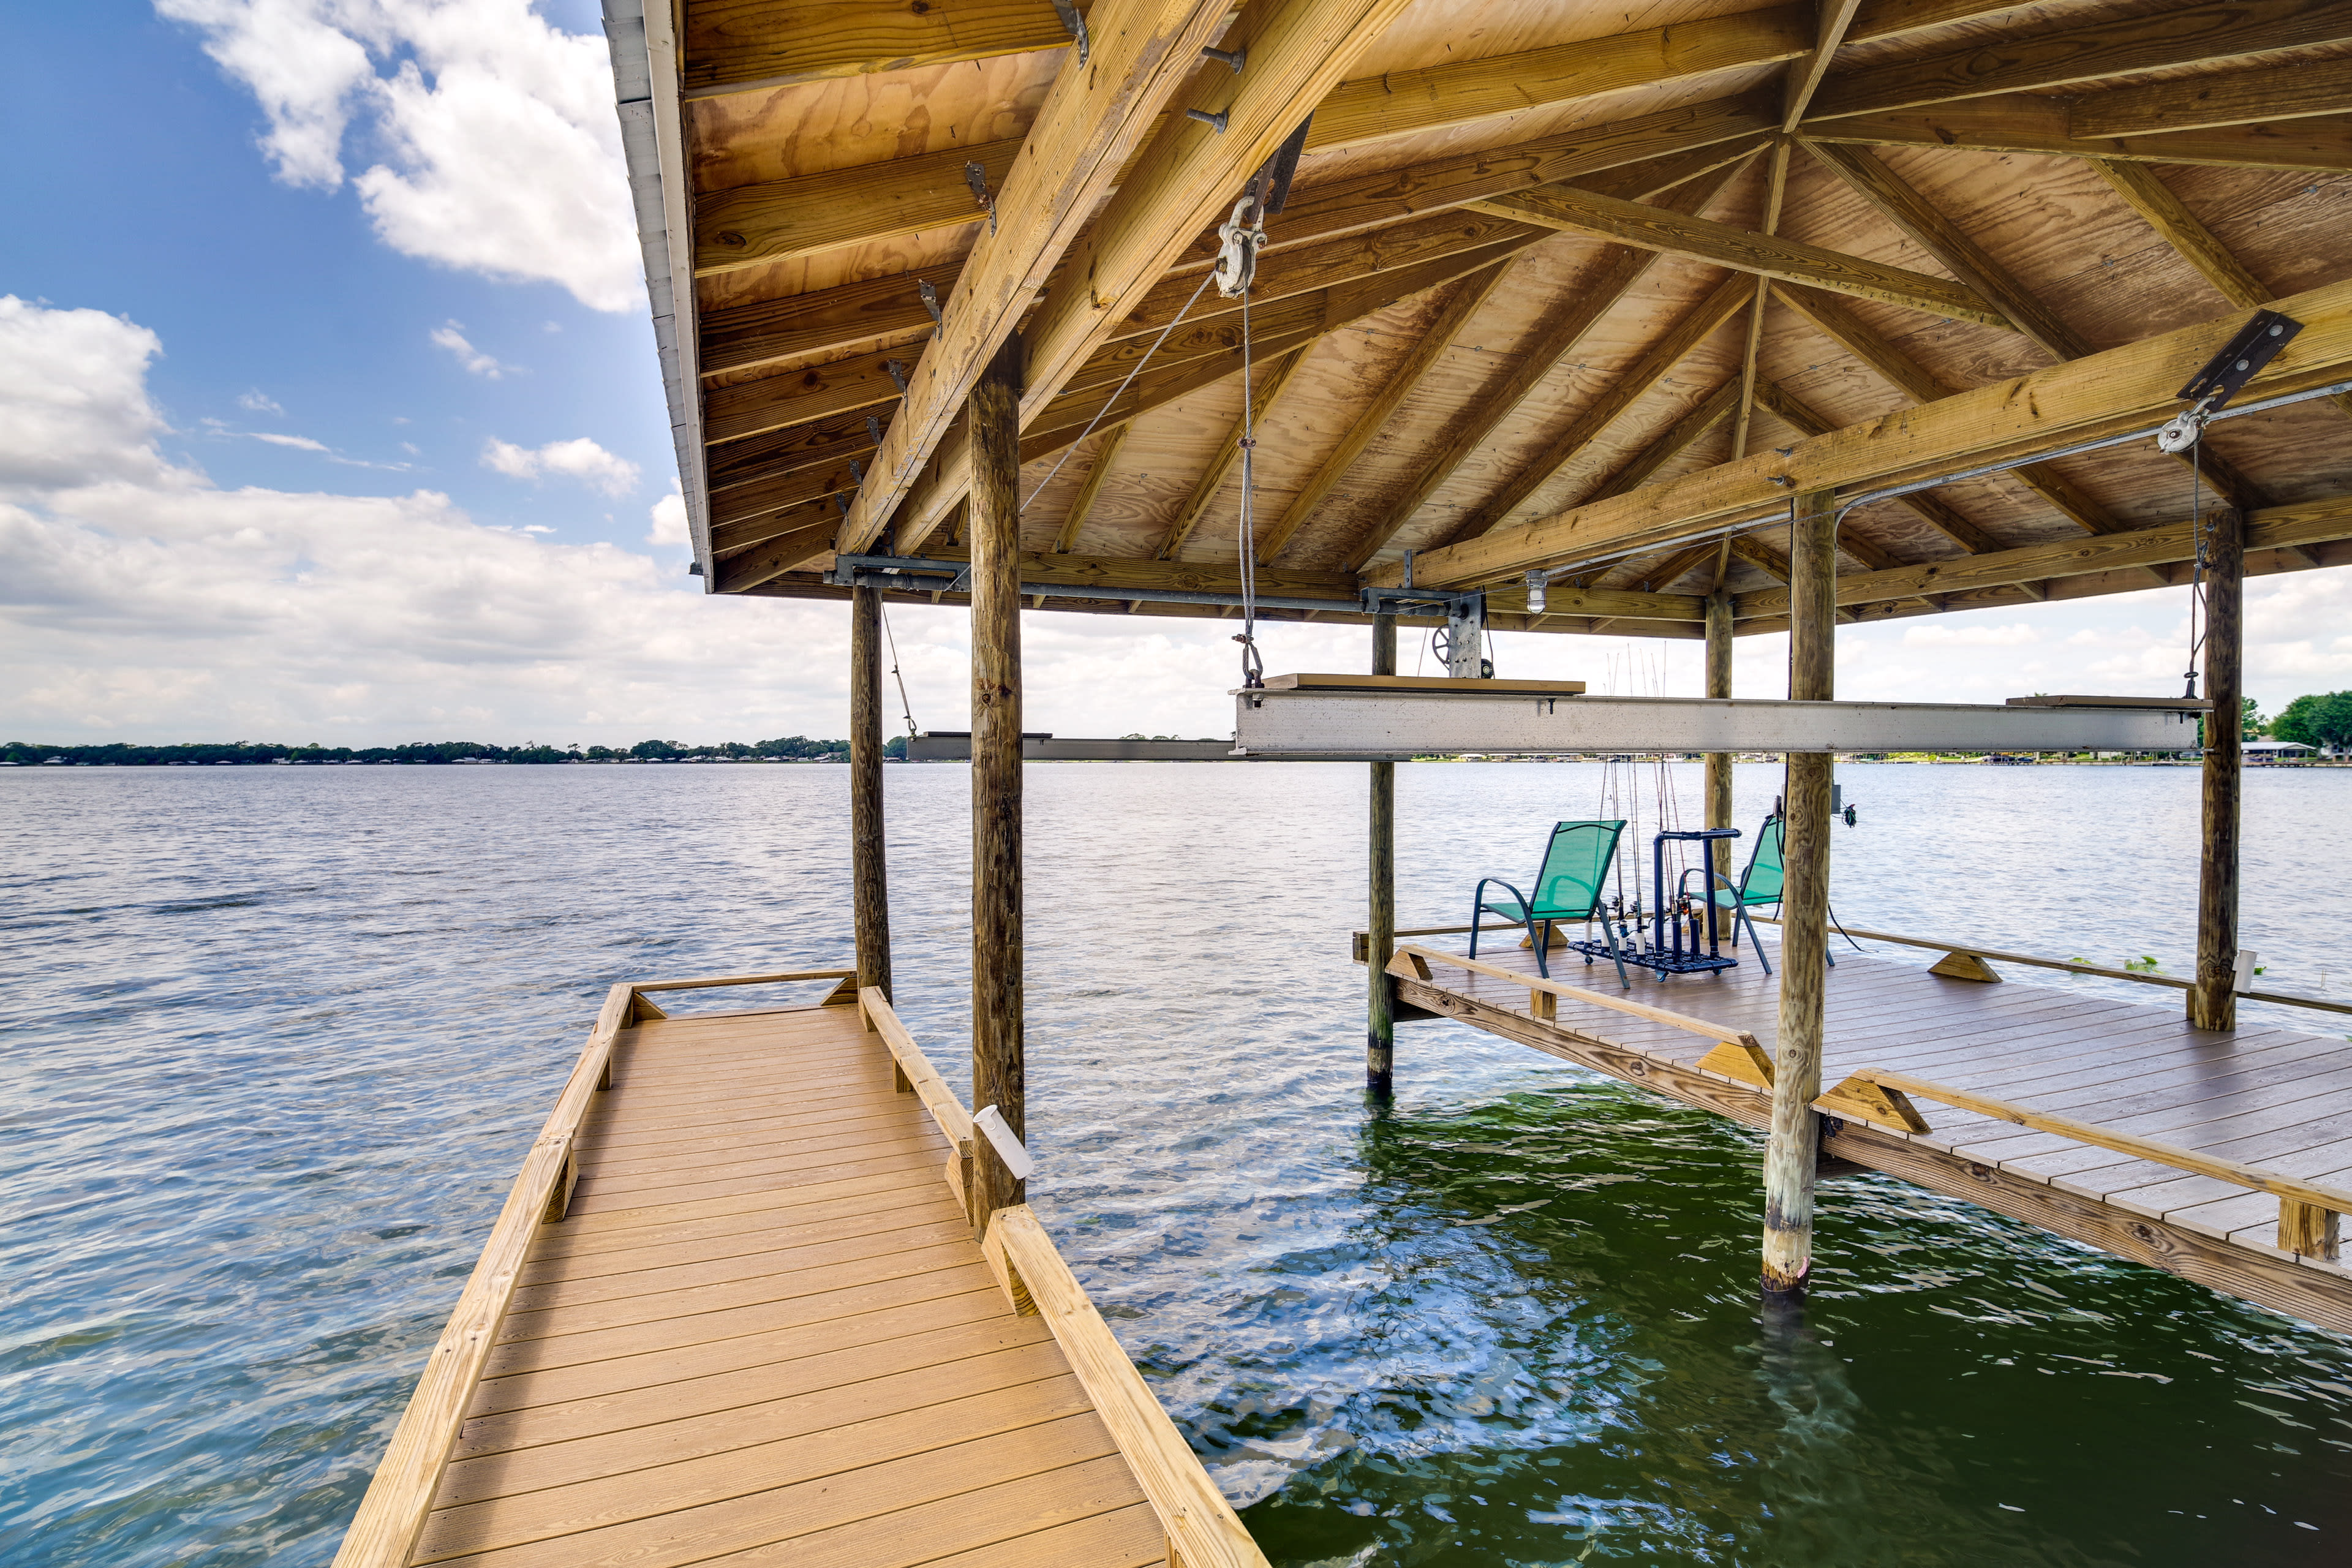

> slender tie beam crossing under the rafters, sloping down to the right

[{"left": 1470, "top": 186, "right": 2008, "bottom": 326}]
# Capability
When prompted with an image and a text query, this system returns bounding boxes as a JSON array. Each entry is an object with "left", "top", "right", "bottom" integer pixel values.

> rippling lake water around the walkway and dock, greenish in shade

[{"left": 0, "top": 764, "right": 2352, "bottom": 1568}]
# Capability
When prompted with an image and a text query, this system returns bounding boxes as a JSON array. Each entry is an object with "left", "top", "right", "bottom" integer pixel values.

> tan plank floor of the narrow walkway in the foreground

[{"left": 426, "top": 1006, "right": 1167, "bottom": 1568}]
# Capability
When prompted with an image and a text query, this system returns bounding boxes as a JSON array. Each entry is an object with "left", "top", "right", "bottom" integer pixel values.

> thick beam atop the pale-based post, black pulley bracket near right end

[{"left": 1381, "top": 282, "right": 2352, "bottom": 588}]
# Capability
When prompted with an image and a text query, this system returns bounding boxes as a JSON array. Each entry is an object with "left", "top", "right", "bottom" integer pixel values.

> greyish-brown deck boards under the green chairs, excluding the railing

[{"left": 1406, "top": 940, "right": 2352, "bottom": 1319}]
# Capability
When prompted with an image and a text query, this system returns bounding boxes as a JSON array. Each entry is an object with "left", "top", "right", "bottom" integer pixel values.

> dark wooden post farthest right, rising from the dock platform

[{"left": 2187, "top": 510, "right": 2246, "bottom": 1030}]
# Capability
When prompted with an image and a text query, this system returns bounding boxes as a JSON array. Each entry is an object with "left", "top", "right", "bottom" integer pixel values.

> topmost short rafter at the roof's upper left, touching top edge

[{"left": 680, "top": 0, "right": 1091, "bottom": 99}]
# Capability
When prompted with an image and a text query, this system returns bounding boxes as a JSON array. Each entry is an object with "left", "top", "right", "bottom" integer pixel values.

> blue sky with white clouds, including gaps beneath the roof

[{"left": 0, "top": 0, "right": 2352, "bottom": 743}]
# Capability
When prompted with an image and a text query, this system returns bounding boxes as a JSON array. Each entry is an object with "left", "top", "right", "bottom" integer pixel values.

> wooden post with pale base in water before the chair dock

[{"left": 1764, "top": 491, "right": 1837, "bottom": 1295}]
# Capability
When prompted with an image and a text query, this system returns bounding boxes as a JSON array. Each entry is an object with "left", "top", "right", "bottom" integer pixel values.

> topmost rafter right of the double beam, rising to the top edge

[{"left": 1308, "top": 0, "right": 1806, "bottom": 153}]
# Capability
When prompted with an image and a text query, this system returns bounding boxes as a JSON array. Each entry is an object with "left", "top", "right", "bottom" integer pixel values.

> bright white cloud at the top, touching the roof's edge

[{"left": 155, "top": 0, "right": 644, "bottom": 311}]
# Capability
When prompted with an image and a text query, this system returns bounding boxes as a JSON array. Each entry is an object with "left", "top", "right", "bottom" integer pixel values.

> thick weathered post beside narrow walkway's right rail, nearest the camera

[{"left": 969, "top": 336, "right": 1028, "bottom": 1237}]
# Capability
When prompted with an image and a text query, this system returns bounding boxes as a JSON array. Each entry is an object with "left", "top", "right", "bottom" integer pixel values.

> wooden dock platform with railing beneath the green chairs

[{"left": 1360, "top": 931, "right": 2352, "bottom": 1330}]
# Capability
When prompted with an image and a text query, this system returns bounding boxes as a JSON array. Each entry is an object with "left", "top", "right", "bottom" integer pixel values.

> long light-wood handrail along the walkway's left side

[{"left": 334, "top": 985, "right": 639, "bottom": 1568}]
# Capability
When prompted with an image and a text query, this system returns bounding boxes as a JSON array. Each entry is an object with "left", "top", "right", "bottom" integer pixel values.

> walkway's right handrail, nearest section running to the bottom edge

[{"left": 988, "top": 1204, "right": 1268, "bottom": 1568}]
